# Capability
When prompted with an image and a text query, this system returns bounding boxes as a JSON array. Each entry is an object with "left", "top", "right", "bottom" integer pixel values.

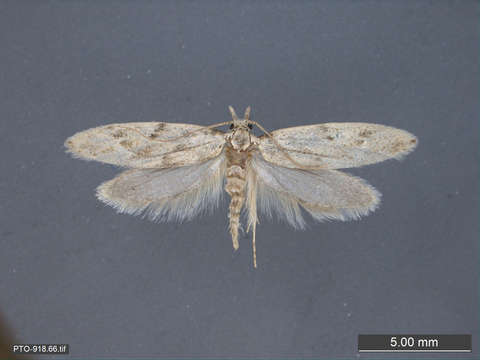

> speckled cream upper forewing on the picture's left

[{"left": 65, "top": 122, "right": 225, "bottom": 168}]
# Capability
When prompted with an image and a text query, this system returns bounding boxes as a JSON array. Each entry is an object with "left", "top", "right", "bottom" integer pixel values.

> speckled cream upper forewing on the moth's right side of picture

[{"left": 259, "top": 123, "right": 417, "bottom": 169}]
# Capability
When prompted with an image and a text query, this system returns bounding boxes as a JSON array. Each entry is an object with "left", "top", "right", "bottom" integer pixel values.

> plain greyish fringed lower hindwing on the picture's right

[{"left": 251, "top": 154, "right": 381, "bottom": 228}]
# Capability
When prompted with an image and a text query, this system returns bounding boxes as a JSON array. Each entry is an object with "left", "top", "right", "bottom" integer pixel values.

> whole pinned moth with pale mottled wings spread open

[{"left": 65, "top": 106, "right": 417, "bottom": 267}]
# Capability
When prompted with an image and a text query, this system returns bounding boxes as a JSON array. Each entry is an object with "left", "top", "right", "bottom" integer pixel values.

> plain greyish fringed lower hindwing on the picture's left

[{"left": 97, "top": 154, "right": 225, "bottom": 221}]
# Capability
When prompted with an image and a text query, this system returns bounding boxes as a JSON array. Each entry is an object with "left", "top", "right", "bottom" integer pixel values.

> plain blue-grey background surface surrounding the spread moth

[{"left": 0, "top": 0, "right": 479, "bottom": 359}]
